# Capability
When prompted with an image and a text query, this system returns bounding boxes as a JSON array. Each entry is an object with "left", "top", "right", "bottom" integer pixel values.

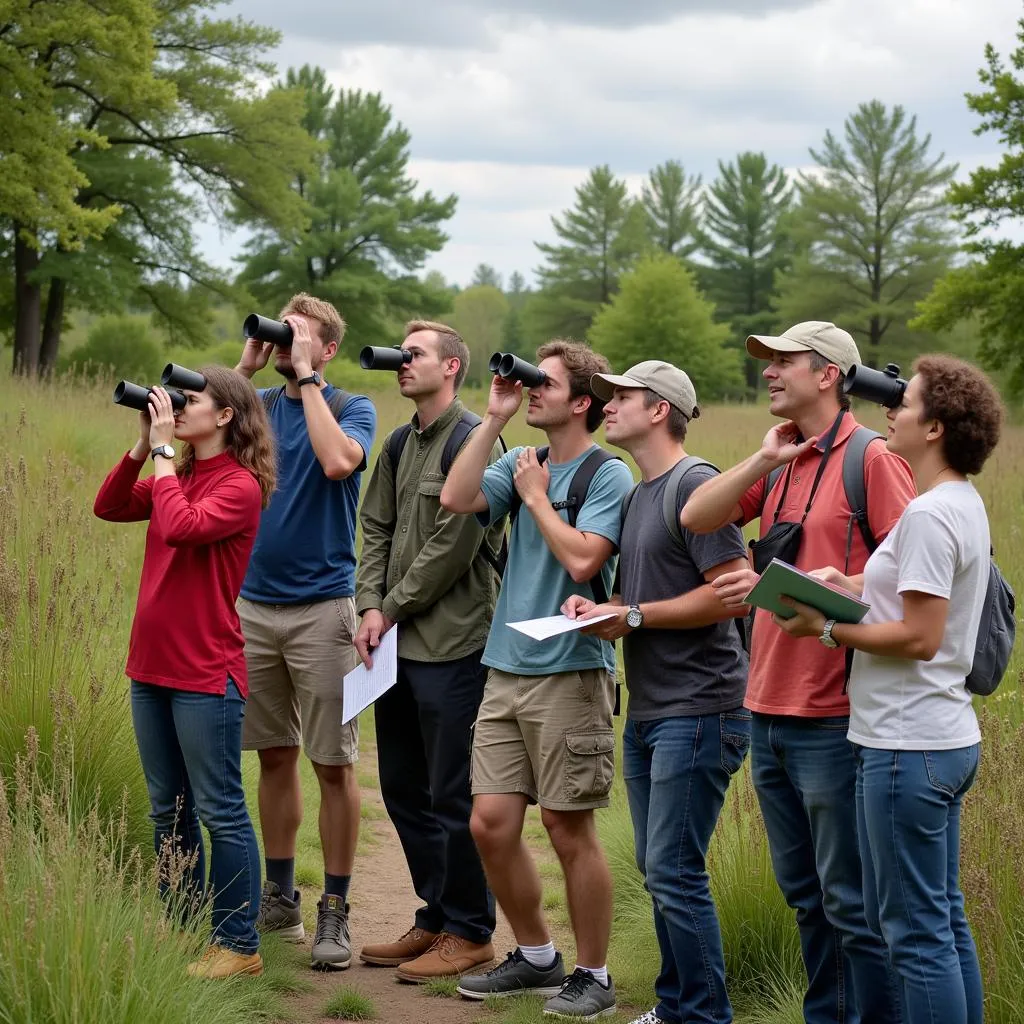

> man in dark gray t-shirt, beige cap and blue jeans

[{"left": 563, "top": 359, "right": 751, "bottom": 1021}]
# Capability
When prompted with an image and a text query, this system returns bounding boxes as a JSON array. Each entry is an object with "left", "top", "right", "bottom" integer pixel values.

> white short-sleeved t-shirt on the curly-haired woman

[{"left": 848, "top": 481, "right": 990, "bottom": 751}]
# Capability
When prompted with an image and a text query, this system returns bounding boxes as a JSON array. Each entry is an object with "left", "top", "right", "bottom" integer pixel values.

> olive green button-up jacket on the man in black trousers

[{"left": 355, "top": 398, "right": 505, "bottom": 662}]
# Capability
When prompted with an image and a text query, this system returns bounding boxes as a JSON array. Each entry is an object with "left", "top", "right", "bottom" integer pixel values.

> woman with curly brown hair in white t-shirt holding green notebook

[{"left": 775, "top": 355, "right": 1001, "bottom": 1024}]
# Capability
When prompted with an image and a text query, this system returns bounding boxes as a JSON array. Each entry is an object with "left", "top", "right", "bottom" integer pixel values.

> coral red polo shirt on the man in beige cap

[{"left": 739, "top": 413, "right": 916, "bottom": 718}]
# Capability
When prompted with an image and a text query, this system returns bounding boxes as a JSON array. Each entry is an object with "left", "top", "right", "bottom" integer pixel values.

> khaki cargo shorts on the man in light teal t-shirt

[{"left": 472, "top": 669, "right": 615, "bottom": 811}]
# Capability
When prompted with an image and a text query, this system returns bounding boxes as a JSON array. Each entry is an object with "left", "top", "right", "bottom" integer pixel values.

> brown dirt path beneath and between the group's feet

[{"left": 268, "top": 749, "right": 572, "bottom": 1024}]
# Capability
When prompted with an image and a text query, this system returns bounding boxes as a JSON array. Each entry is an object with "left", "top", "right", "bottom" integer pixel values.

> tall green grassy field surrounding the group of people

[{"left": 0, "top": 365, "right": 1024, "bottom": 1024}]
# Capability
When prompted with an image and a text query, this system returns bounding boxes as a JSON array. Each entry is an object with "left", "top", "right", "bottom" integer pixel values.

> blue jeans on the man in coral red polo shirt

[{"left": 751, "top": 713, "right": 901, "bottom": 1024}]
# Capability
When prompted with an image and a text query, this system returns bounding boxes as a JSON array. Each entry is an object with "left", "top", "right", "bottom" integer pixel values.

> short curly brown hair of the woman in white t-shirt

[{"left": 913, "top": 355, "right": 1002, "bottom": 476}]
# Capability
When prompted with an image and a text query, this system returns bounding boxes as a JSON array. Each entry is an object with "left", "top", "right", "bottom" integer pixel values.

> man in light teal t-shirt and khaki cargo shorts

[{"left": 441, "top": 341, "right": 633, "bottom": 1019}]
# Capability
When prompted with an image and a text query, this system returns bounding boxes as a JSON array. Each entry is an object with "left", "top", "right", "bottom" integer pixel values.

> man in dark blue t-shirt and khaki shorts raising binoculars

[{"left": 236, "top": 293, "right": 377, "bottom": 969}]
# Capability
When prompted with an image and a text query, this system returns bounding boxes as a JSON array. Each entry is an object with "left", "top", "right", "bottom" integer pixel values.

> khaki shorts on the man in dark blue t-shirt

[{"left": 237, "top": 597, "right": 359, "bottom": 765}]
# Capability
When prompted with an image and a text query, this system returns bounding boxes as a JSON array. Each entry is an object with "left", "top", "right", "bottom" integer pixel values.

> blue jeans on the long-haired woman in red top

[{"left": 131, "top": 679, "right": 260, "bottom": 953}]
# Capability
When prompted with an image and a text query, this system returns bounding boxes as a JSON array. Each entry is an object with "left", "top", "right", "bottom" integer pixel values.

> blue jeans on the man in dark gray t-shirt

[{"left": 623, "top": 708, "right": 751, "bottom": 1024}]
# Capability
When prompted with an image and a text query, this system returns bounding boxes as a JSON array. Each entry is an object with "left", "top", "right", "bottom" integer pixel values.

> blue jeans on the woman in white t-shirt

[{"left": 854, "top": 743, "right": 982, "bottom": 1024}]
